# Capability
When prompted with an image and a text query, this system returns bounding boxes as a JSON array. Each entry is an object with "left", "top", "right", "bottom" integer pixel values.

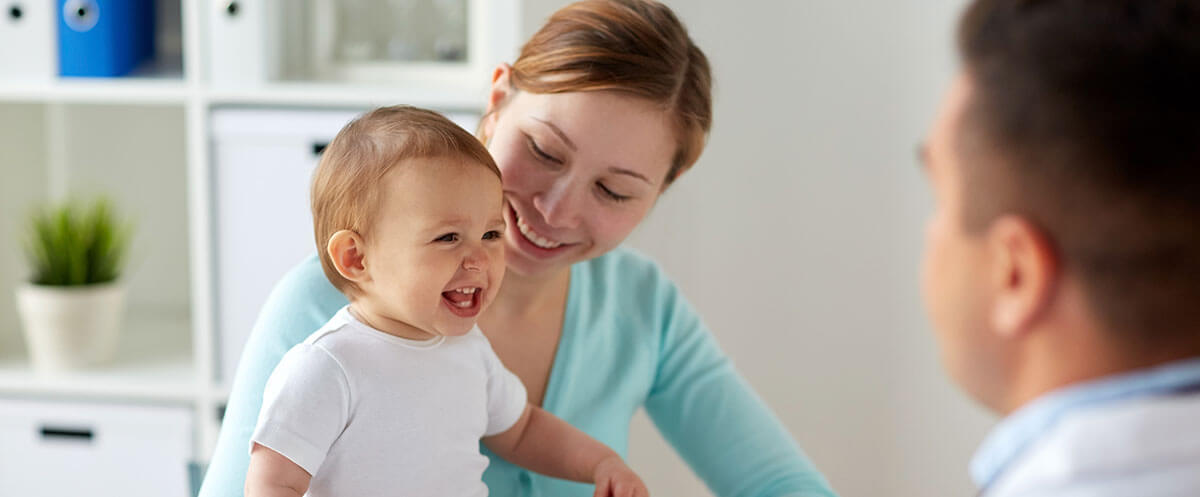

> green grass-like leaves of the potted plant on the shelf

[{"left": 25, "top": 198, "right": 132, "bottom": 286}]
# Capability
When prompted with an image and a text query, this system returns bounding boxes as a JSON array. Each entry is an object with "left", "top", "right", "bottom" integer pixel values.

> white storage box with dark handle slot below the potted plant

[{"left": 0, "top": 399, "right": 193, "bottom": 497}]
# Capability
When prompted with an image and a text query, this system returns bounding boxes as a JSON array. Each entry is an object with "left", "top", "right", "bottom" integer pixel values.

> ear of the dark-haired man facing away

[{"left": 986, "top": 216, "right": 1062, "bottom": 339}]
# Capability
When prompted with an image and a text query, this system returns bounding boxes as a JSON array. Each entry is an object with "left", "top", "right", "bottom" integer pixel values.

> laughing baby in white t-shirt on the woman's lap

[{"left": 246, "top": 107, "right": 648, "bottom": 497}]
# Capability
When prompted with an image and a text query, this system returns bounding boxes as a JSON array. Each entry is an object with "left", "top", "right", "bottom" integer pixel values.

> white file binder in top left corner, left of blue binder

[{"left": 0, "top": 0, "right": 59, "bottom": 80}]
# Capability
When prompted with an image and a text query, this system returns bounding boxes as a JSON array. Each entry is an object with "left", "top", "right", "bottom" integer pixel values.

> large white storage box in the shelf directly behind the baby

[{"left": 212, "top": 109, "right": 479, "bottom": 384}]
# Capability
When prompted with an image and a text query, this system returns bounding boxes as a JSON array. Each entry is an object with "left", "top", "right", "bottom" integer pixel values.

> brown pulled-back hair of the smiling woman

[{"left": 511, "top": 0, "right": 713, "bottom": 184}]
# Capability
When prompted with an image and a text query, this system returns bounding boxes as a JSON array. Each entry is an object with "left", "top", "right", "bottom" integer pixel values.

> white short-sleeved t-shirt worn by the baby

[{"left": 251, "top": 307, "right": 526, "bottom": 497}]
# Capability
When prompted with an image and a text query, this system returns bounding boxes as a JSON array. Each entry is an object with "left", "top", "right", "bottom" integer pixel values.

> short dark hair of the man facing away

[{"left": 956, "top": 0, "right": 1200, "bottom": 353}]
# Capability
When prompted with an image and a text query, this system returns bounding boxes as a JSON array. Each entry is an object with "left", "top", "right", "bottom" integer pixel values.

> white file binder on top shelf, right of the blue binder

[{"left": 205, "top": 0, "right": 280, "bottom": 88}]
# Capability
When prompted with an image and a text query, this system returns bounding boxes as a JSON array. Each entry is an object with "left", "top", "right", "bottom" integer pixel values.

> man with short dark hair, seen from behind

[{"left": 923, "top": 0, "right": 1200, "bottom": 497}]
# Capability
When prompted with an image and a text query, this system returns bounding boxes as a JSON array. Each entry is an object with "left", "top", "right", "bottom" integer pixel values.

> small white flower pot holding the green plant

[{"left": 17, "top": 282, "right": 125, "bottom": 372}]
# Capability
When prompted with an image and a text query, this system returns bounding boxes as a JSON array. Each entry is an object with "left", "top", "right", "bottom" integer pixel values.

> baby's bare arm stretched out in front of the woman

[{"left": 484, "top": 405, "right": 649, "bottom": 497}]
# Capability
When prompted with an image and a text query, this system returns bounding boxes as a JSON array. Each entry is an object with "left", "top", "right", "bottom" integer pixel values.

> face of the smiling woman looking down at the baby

[{"left": 484, "top": 87, "right": 676, "bottom": 276}]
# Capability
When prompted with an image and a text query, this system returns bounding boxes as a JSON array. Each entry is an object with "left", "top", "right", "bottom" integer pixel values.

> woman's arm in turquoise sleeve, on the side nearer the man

[{"left": 646, "top": 281, "right": 834, "bottom": 497}]
